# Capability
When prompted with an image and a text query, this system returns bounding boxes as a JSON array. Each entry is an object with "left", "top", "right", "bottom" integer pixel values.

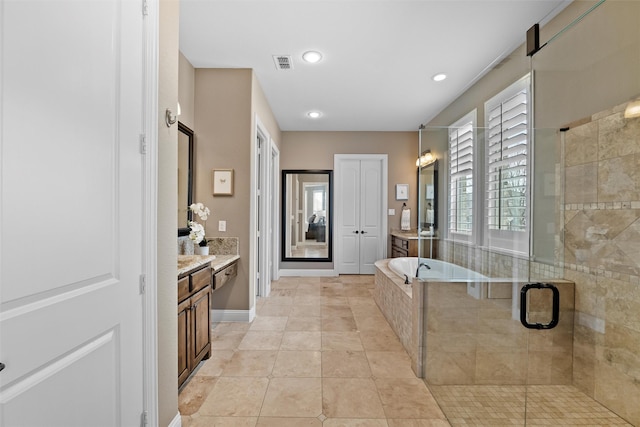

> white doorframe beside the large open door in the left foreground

[{"left": 140, "top": 0, "right": 159, "bottom": 426}]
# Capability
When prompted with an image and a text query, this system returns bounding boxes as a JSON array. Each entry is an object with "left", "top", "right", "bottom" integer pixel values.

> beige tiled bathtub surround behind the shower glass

[{"left": 374, "top": 260, "right": 574, "bottom": 385}]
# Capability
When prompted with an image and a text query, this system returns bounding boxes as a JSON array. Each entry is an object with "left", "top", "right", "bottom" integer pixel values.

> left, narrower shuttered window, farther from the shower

[{"left": 449, "top": 110, "right": 476, "bottom": 240}]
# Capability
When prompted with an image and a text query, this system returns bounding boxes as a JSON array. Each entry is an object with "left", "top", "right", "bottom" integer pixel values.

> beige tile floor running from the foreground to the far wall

[{"left": 179, "top": 276, "right": 625, "bottom": 427}]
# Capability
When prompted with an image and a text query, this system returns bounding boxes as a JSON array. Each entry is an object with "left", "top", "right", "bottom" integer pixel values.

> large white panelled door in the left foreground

[{"left": 0, "top": 0, "right": 144, "bottom": 427}]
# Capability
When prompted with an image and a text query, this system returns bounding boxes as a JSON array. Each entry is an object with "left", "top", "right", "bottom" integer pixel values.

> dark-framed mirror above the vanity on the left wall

[{"left": 178, "top": 122, "right": 194, "bottom": 236}]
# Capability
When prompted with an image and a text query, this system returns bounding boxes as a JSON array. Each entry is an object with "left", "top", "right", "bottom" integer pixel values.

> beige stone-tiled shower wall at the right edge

[{"left": 564, "top": 104, "right": 640, "bottom": 425}]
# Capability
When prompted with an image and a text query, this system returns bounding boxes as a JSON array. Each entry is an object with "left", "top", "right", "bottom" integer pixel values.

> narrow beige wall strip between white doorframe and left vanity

[{"left": 157, "top": 0, "right": 179, "bottom": 426}]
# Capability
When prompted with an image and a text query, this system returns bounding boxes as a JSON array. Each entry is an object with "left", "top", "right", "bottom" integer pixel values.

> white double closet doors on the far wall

[{"left": 336, "top": 155, "right": 387, "bottom": 274}]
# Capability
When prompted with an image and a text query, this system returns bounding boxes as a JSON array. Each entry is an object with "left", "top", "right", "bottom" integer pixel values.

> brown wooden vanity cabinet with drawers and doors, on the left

[{"left": 178, "top": 264, "right": 213, "bottom": 386}]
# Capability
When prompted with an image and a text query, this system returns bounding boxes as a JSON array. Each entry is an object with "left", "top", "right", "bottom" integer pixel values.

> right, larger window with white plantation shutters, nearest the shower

[{"left": 486, "top": 85, "right": 529, "bottom": 231}]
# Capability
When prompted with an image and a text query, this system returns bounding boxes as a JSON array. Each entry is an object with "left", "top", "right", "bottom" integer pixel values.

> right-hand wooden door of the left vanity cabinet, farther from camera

[{"left": 191, "top": 286, "right": 212, "bottom": 368}]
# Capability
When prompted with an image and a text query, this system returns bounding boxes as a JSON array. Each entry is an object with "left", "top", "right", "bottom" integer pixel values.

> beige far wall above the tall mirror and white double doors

[{"left": 280, "top": 130, "right": 418, "bottom": 258}]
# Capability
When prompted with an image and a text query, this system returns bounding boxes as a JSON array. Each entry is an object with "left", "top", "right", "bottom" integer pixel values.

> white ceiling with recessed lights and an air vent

[{"left": 180, "top": 0, "right": 570, "bottom": 131}]
